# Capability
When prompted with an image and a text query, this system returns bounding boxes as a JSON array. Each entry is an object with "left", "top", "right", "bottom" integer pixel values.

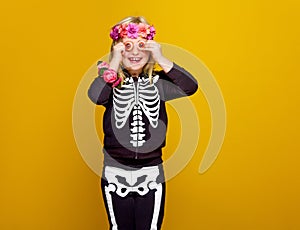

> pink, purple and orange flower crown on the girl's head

[{"left": 110, "top": 23, "right": 156, "bottom": 41}]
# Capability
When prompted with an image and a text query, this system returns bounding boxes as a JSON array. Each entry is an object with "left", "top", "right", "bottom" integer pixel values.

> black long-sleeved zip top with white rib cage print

[{"left": 88, "top": 62, "right": 198, "bottom": 164}]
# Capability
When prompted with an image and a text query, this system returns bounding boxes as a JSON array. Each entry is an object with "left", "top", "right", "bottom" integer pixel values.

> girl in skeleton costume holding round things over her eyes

[{"left": 88, "top": 17, "right": 198, "bottom": 230}]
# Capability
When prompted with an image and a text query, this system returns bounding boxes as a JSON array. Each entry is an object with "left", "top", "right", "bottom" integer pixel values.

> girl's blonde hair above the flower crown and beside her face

[{"left": 109, "top": 16, "right": 155, "bottom": 84}]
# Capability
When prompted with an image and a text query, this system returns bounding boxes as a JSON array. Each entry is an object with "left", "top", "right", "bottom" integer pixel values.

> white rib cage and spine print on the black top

[{"left": 113, "top": 75, "right": 160, "bottom": 147}]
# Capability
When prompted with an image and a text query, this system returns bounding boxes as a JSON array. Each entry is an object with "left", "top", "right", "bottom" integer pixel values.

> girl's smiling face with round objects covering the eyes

[{"left": 122, "top": 38, "right": 150, "bottom": 74}]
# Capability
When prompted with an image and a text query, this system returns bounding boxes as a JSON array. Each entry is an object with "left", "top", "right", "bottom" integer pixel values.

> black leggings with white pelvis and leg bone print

[{"left": 101, "top": 165, "right": 165, "bottom": 230}]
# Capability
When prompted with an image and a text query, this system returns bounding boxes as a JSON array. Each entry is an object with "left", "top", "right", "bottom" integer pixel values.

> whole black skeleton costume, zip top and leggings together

[{"left": 88, "top": 62, "right": 198, "bottom": 230}]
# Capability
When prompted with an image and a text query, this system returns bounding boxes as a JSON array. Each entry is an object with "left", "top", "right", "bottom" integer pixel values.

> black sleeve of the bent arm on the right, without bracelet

[{"left": 159, "top": 63, "right": 198, "bottom": 101}]
